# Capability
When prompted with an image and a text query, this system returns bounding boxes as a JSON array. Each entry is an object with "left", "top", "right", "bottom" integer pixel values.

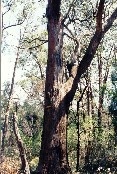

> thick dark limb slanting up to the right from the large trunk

[{"left": 63, "top": 2, "right": 117, "bottom": 104}]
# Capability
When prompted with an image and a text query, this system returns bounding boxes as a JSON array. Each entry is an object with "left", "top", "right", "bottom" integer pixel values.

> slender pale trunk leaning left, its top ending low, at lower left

[{"left": 13, "top": 112, "right": 30, "bottom": 174}]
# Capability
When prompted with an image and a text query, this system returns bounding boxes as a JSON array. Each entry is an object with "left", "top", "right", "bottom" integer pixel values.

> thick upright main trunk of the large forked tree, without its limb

[{"left": 38, "top": 0, "right": 70, "bottom": 174}]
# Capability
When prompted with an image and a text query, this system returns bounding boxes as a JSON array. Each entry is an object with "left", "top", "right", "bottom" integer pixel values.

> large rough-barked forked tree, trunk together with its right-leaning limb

[{"left": 37, "top": 0, "right": 117, "bottom": 174}]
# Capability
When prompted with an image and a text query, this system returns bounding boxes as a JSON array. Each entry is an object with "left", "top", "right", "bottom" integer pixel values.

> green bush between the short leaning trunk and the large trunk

[{"left": 19, "top": 101, "right": 43, "bottom": 159}]
